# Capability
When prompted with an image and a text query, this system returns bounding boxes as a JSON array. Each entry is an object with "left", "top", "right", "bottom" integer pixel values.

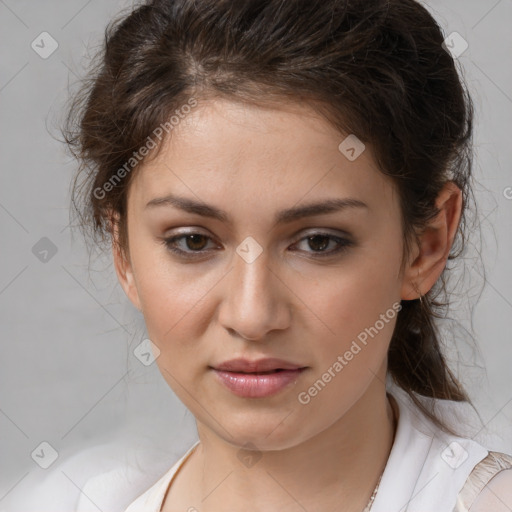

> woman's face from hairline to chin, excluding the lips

[{"left": 116, "top": 100, "right": 416, "bottom": 449}]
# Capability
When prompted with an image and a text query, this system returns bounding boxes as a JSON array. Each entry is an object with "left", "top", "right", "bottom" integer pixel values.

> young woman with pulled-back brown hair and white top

[{"left": 66, "top": 0, "right": 512, "bottom": 512}]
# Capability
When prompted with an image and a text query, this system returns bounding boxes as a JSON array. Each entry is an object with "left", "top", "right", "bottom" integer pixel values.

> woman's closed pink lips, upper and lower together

[{"left": 209, "top": 358, "right": 306, "bottom": 398}]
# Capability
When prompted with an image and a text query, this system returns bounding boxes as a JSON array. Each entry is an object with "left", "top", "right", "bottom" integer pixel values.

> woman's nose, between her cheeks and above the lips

[{"left": 219, "top": 246, "right": 290, "bottom": 341}]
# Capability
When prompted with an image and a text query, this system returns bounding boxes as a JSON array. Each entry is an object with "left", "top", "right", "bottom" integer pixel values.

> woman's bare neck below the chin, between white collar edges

[{"left": 166, "top": 372, "right": 395, "bottom": 512}]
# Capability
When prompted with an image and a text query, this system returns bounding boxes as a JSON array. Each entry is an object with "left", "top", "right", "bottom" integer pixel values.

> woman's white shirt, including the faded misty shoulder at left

[{"left": 13, "top": 387, "right": 512, "bottom": 512}]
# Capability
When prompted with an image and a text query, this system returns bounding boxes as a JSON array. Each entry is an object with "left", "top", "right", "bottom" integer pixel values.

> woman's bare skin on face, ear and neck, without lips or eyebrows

[{"left": 113, "top": 99, "right": 462, "bottom": 512}]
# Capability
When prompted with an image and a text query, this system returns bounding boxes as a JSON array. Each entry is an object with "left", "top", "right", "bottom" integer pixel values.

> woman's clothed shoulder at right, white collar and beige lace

[{"left": 386, "top": 390, "right": 512, "bottom": 512}]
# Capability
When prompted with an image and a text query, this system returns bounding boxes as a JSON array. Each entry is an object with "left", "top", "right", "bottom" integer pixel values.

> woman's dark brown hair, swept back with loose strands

[{"left": 62, "top": 0, "right": 484, "bottom": 432}]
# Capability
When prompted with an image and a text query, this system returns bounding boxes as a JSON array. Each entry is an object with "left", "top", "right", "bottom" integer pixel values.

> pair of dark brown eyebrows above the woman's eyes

[{"left": 144, "top": 194, "right": 369, "bottom": 224}]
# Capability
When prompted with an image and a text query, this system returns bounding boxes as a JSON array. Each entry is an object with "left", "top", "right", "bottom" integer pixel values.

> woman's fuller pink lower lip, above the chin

[{"left": 210, "top": 368, "right": 306, "bottom": 398}]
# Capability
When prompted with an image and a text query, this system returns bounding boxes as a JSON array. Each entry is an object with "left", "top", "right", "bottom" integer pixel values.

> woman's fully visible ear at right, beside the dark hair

[{"left": 401, "top": 181, "right": 462, "bottom": 300}]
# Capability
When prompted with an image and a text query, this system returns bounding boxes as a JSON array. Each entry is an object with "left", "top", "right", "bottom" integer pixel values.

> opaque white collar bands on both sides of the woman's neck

[{"left": 125, "top": 393, "right": 489, "bottom": 512}]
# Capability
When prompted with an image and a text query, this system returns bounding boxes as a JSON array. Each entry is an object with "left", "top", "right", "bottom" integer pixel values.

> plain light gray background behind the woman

[{"left": 0, "top": 0, "right": 512, "bottom": 512}]
